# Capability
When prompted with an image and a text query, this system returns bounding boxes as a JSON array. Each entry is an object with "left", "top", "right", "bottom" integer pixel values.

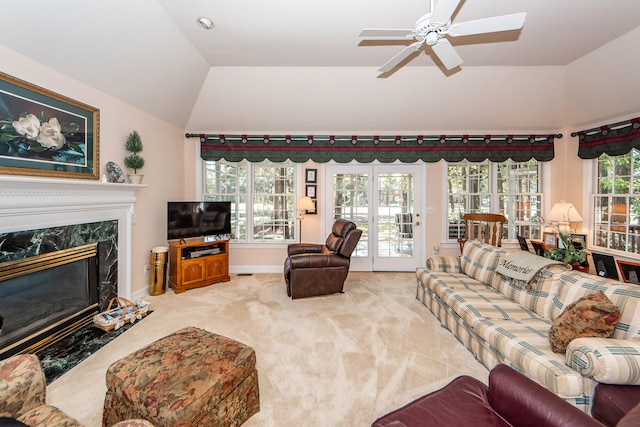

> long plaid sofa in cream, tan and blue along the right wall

[{"left": 416, "top": 241, "right": 640, "bottom": 412}]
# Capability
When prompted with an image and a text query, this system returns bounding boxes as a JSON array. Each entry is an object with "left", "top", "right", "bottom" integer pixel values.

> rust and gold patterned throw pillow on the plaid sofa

[{"left": 549, "top": 291, "right": 620, "bottom": 353}]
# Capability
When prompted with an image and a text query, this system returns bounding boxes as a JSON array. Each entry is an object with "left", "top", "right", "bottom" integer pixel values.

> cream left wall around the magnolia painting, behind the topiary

[{"left": 0, "top": 46, "right": 185, "bottom": 295}]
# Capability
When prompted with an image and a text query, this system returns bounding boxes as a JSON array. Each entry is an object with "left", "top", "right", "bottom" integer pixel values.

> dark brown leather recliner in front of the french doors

[{"left": 284, "top": 218, "right": 362, "bottom": 299}]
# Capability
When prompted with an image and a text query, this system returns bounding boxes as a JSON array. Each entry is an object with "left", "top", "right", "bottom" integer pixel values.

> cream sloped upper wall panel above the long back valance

[{"left": 187, "top": 67, "right": 565, "bottom": 134}]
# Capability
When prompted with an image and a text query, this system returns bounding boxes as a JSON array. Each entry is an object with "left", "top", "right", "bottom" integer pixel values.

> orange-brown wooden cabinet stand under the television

[{"left": 169, "top": 239, "right": 229, "bottom": 294}]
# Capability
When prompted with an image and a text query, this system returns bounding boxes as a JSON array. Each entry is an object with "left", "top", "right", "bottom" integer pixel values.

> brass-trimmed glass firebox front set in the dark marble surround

[{"left": 0, "top": 244, "right": 98, "bottom": 358}]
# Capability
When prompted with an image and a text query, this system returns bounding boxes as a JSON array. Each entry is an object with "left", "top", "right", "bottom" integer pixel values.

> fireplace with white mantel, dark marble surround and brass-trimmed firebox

[{"left": 0, "top": 175, "right": 145, "bottom": 359}]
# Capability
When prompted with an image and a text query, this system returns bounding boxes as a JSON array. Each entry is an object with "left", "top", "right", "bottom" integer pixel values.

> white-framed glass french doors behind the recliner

[{"left": 323, "top": 164, "right": 424, "bottom": 271}]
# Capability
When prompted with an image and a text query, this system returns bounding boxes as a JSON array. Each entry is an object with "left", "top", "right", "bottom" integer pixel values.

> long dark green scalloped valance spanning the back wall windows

[{"left": 191, "top": 133, "right": 562, "bottom": 163}]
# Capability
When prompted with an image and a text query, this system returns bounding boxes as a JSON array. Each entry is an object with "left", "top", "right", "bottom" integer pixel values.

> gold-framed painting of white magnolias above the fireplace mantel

[{"left": 0, "top": 73, "right": 100, "bottom": 179}]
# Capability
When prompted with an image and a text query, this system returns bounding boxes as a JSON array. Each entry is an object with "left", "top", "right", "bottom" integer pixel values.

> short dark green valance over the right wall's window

[{"left": 571, "top": 118, "right": 640, "bottom": 159}]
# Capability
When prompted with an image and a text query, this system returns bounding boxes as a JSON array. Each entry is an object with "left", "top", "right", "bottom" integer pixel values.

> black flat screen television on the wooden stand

[{"left": 167, "top": 202, "right": 231, "bottom": 240}]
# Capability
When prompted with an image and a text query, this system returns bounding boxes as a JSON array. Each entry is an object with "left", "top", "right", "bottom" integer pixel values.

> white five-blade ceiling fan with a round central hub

[{"left": 360, "top": 0, "right": 527, "bottom": 73}]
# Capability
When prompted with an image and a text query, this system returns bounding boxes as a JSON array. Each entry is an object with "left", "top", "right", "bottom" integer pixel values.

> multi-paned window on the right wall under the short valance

[{"left": 592, "top": 149, "right": 640, "bottom": 254}]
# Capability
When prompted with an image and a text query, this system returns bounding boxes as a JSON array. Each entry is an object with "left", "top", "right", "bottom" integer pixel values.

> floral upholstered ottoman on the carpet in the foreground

[{"left": 102, "top": 327, "right": 260, "bottom": 427}]
